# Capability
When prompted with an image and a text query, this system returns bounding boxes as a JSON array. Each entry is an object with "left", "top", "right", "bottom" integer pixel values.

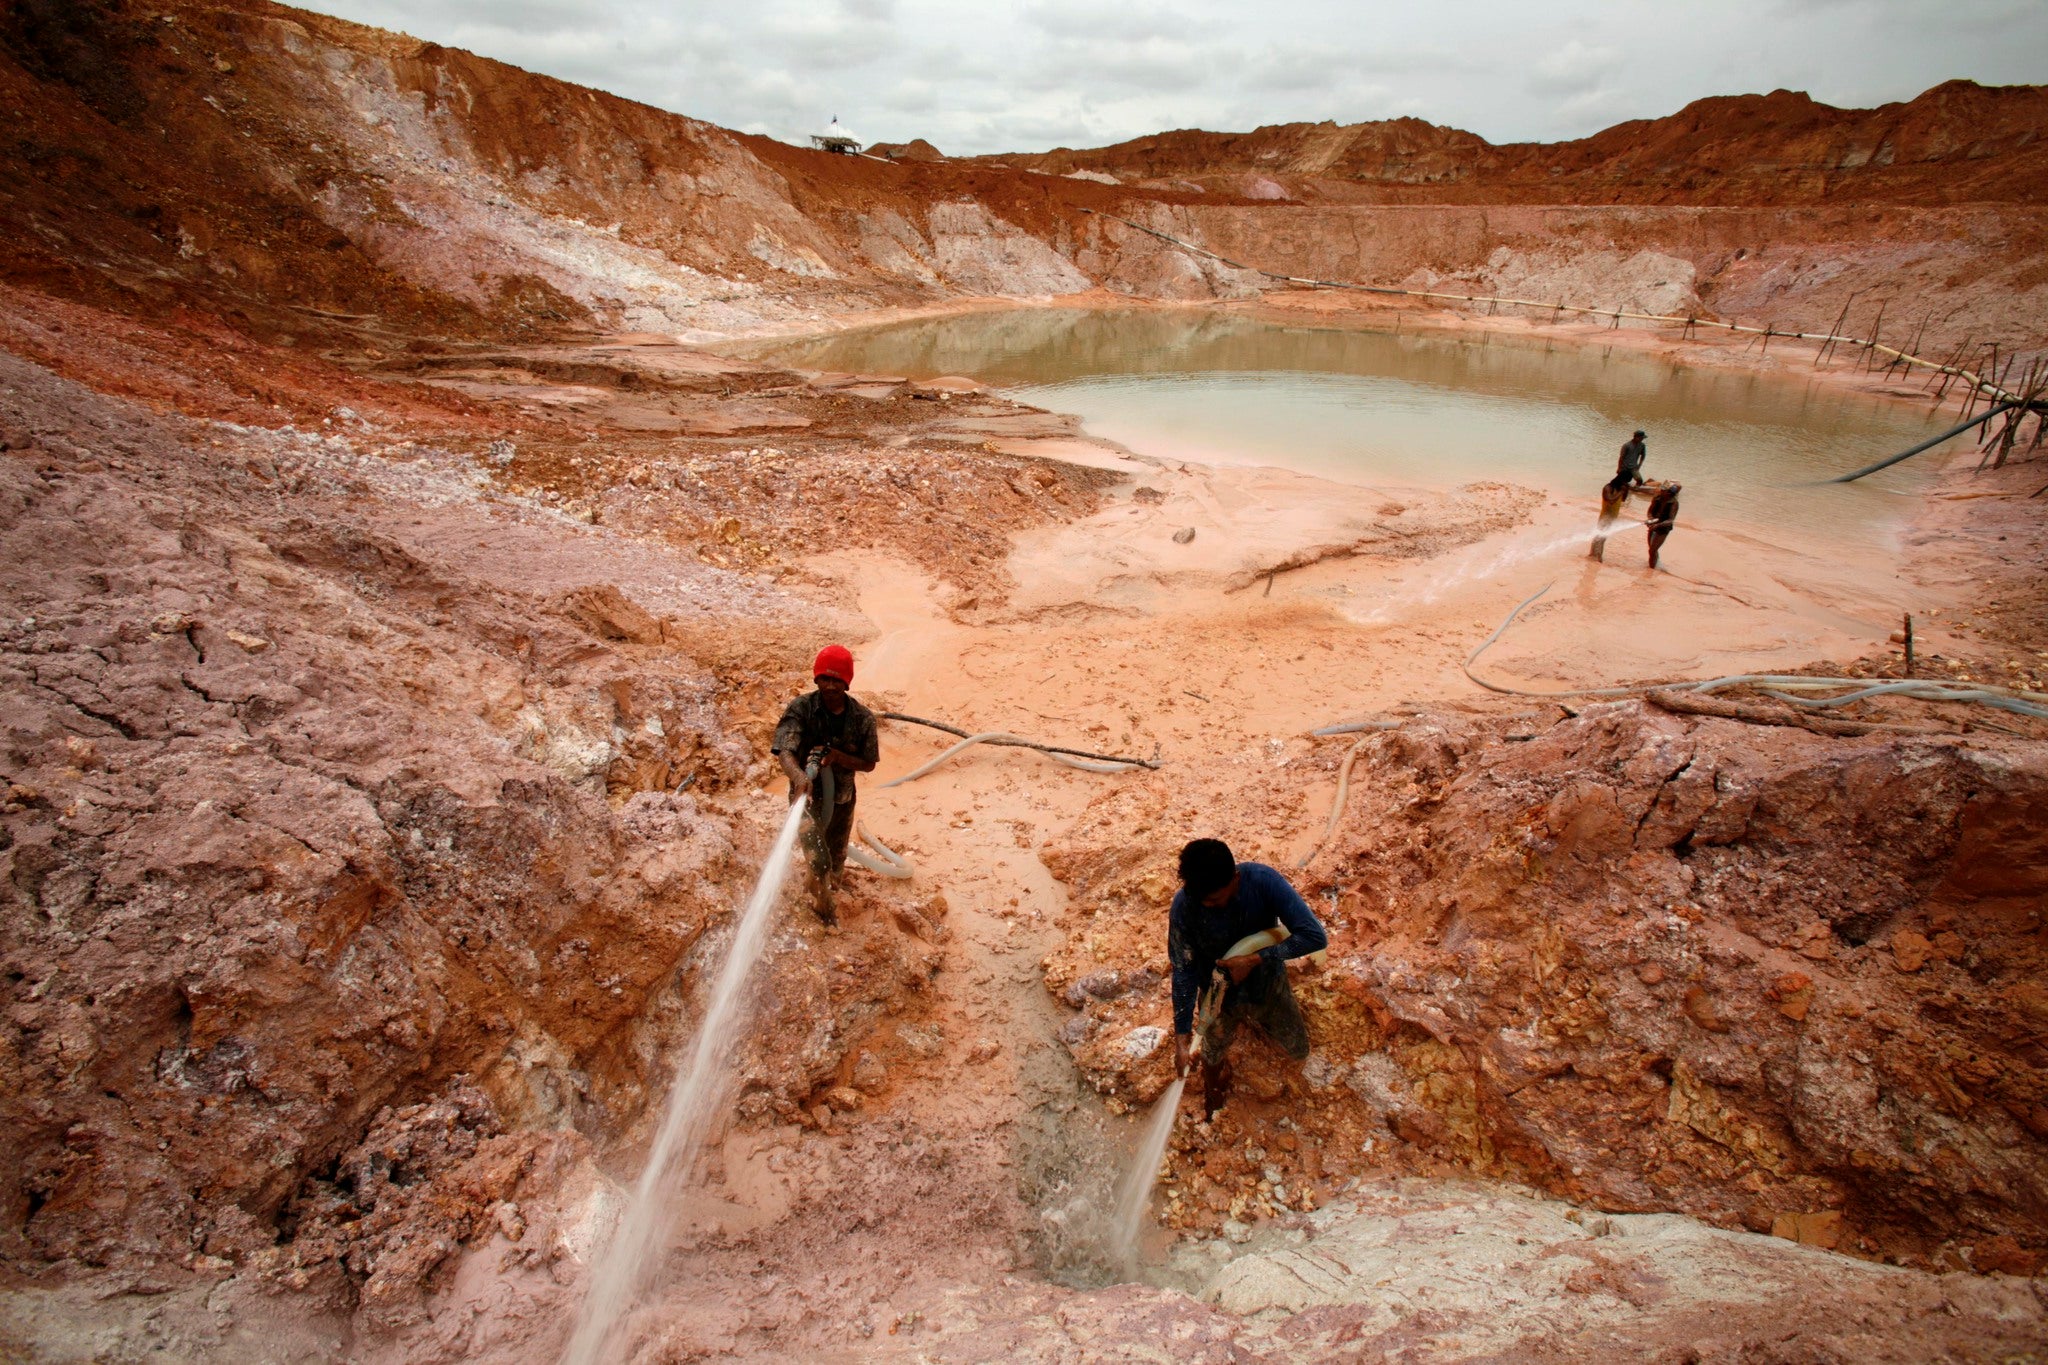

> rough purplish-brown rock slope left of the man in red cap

[{"left": 0, "top": 360, "right": 770, "bottom": 1263}]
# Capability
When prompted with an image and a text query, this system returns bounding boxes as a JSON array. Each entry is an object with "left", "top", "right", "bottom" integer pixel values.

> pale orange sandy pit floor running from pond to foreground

[{"left": 10, "top": 294, "right": 2044, "bottom": 1363}]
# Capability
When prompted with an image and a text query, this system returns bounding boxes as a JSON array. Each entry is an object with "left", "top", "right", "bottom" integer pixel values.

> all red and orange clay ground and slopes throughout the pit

[{"left": 0, "top": 0, "right": 2048, "bottom": 1361}]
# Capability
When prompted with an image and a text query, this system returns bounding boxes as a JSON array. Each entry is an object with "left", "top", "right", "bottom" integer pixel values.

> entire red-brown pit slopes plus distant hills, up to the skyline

[{"left": 0, "top": 0, "right": 2048, "bottom": 362}]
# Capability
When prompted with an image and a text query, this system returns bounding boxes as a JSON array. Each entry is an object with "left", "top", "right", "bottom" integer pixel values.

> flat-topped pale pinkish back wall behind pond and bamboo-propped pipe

[{"left": 1071, "top": 203, "right": 2048, "bottom": 354}]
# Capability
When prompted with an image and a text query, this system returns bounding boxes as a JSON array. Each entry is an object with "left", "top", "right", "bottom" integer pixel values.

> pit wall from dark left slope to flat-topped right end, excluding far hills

[{"left": 0, "top": 0, "right": 2048, "bottom": 352}]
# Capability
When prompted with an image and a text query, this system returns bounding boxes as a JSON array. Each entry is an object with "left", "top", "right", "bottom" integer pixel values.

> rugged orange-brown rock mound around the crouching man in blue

[{"left": 1049, "top": 704, "right": 2048, "bottom": 1269}]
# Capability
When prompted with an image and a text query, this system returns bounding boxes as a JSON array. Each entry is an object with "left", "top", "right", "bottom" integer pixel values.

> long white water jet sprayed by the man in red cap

[{"left": 561, "top": 800, "right": 807, "bottom": 1365}]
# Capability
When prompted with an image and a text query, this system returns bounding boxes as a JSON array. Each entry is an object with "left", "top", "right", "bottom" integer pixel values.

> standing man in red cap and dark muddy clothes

[{"left": 774, "top": 645, "right": 881, "bottom": 925}]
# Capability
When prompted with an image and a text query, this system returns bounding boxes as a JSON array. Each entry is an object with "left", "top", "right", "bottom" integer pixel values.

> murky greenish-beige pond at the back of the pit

[{"left": 754, "top": 309, "right": 1944, "bottom": 538}]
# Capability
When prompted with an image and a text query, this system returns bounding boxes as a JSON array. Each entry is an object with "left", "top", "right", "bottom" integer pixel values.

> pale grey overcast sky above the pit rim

[{"left": 288, "top": 0, "right": 2048, "bottom": 156}]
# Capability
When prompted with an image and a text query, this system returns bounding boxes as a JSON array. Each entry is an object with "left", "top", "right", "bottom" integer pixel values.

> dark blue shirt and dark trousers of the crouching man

[{"left": 1165, "top": 864, "right": 1329, "bottom": 1035}]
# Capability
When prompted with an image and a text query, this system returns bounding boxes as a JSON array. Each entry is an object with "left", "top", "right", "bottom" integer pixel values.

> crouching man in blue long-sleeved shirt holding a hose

[{"left": 1165, "top": 839, "right": 1329, "bottom": 1117}]
